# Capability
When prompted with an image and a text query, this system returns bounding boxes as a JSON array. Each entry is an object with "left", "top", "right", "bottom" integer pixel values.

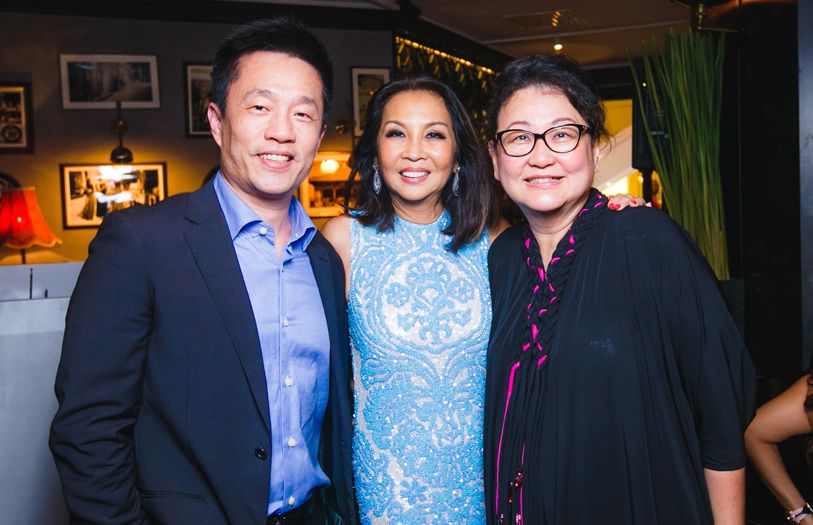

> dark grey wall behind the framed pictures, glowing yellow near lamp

[{"left": 0, "top": 12, "right": 393, "bottom": 262}]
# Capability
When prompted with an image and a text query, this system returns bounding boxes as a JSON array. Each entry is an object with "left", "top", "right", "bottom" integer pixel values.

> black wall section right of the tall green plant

[{"left": 721, "top": 4, "right": 802, "bottom": 376}]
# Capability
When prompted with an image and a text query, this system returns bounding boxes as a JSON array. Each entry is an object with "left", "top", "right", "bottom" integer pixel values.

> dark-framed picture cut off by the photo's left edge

[{"left": 0, "top": 82, "right": 34, "bottom": 153}]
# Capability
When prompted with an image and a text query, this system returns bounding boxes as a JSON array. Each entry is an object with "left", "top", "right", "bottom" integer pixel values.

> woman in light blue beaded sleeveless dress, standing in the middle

[{"left": 323, "top": 77, "right": 505, "bottom": 525}]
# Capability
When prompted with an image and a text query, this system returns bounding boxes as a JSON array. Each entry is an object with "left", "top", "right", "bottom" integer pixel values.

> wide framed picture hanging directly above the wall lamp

[{"left": 59, "top": 55, "right": 161, "bottom": 109}]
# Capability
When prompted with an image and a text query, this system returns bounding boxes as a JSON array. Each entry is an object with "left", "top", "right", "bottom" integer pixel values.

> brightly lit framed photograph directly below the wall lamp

[{"left": 59, "top": 162, "right": 167, "bottom": 229}]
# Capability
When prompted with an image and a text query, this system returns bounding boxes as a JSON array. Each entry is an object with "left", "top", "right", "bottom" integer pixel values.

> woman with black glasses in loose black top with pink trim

[{"left": 485, "top": 56, "right": 755, "bottom": 525}]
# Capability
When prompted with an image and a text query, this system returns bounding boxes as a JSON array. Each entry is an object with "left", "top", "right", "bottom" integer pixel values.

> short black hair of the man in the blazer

[{"left": 212, "top": 16, "right": 333, "bottom": 123}]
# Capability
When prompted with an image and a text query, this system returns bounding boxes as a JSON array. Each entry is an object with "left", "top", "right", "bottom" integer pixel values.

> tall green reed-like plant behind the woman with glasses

[{"left": 629, "top": 31, "right": 729, "bottom": 279}]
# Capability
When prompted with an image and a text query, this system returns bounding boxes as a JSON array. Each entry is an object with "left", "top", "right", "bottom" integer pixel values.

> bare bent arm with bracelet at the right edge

[{"left": 745, "top": 374, "right": 813, "bottom": 525}]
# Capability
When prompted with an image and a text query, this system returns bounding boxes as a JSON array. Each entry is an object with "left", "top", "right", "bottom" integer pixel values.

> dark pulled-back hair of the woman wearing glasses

[{"left": 488, "top": 55, "right": 609, "bottom": 143}]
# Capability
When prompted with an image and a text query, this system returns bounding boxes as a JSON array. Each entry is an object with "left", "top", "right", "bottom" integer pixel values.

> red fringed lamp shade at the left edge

[{"left": 0, "top": 188, "right": 62, "bottom": 250}]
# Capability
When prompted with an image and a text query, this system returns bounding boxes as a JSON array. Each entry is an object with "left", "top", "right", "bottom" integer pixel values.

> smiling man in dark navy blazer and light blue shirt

[{"left": 50, "top": 19, "right": 356, "bottom": 525}]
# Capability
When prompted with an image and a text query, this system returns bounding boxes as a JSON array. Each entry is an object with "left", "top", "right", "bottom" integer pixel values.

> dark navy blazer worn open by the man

[{"left": 50, "top": 182, "right": 356, "bottom": 525}]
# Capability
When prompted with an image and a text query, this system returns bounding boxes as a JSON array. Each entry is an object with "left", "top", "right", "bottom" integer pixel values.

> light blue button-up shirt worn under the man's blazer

[{"left": 214, "top": 172, "right": 330, "bottom": 515}]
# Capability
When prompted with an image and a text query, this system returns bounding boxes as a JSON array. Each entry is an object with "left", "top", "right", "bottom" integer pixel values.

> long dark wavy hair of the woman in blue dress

[{"left": 346, "top": 77, "right": 499, "bottom": 252}]
